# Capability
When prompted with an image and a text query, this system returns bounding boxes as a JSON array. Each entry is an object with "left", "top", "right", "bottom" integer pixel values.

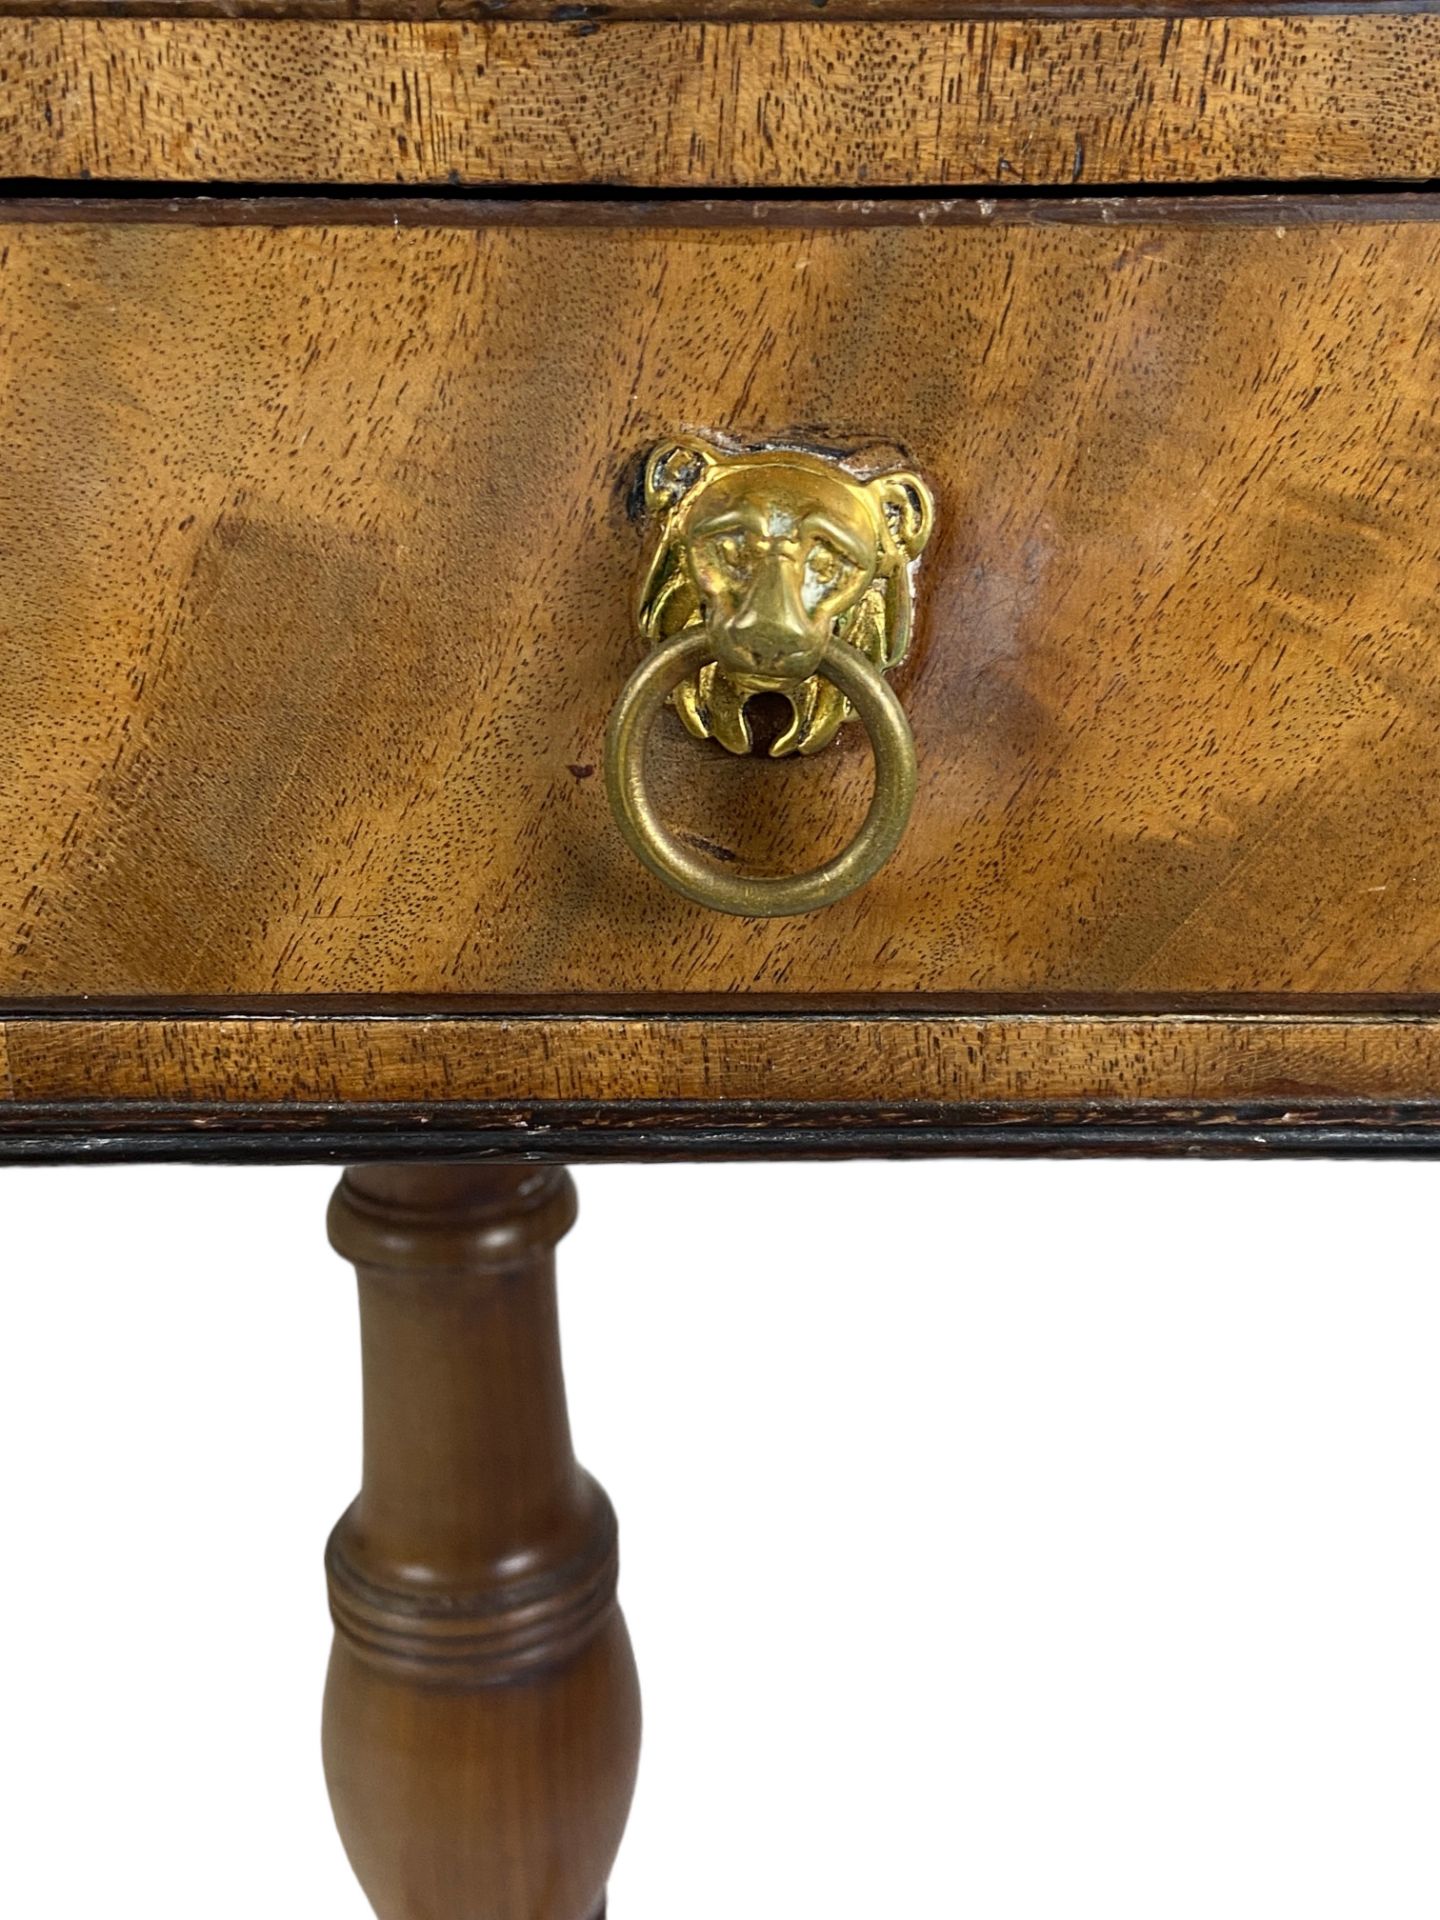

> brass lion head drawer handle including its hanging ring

[{"left": 605, "top": 438, "right": 935, "bottom": 916}]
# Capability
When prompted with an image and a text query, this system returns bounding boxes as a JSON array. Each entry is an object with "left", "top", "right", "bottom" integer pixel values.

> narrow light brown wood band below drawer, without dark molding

[{"left": 4, "top": 1014, "right": 1440, "bottom": 1105}]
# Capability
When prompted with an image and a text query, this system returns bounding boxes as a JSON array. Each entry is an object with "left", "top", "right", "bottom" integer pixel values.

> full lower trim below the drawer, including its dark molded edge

[{"left": 0, "top": 1008, "right": 1440, "bottom": 1162}]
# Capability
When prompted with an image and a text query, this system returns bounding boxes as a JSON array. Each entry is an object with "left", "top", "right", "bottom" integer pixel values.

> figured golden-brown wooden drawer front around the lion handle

[{"left": 0, "top": 200, "right": 1440, "bottom": 998}]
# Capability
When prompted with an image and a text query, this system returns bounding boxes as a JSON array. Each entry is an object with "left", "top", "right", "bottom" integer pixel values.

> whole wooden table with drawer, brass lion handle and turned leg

[{"left": 0, "top": 0, "right": 1440, "bottom": 1920}]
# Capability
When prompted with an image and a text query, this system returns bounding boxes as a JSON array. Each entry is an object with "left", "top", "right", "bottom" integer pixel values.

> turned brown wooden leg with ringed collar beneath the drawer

[{"left": 324, "top": 1165, "right": 639, "bottom": 1920}]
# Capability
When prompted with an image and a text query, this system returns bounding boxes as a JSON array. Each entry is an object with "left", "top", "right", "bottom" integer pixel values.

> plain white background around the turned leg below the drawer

[{"left": 0, "top": 1162, "right": 1440, "bottom": 1920}]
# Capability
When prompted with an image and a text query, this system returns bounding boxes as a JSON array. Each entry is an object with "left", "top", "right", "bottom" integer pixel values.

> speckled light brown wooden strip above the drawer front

[{"left": 0, "top": 13, "right": 1440, "bottom": 190}]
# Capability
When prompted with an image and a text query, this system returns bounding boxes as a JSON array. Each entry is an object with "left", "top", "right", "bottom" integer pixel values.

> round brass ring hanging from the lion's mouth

[{"left": 605, "top": 626, "right": 916, "bottom": 918}]
